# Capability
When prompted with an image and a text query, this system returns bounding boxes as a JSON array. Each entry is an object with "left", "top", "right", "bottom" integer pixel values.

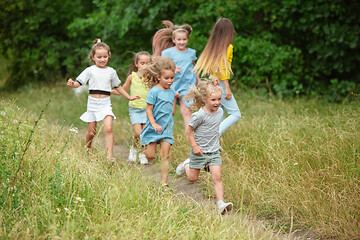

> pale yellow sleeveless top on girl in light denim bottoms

[{"left": 129, "top": 72, "right": 149, "bottom": 108}]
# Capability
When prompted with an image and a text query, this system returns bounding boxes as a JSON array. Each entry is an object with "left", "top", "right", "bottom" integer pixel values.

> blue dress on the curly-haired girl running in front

[{"left": 140, "top": 86, "right": 175, "bottom": 145}]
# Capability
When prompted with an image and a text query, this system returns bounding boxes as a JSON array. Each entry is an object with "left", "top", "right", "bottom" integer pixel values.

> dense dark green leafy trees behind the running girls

[{"left": 0, "top": 0, "right": 360, "bottom": 102}]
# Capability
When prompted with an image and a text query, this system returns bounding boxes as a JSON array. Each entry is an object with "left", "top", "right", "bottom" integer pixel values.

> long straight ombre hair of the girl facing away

[{"left": 194, "top": 18, "right": 235, "bottom": 76}]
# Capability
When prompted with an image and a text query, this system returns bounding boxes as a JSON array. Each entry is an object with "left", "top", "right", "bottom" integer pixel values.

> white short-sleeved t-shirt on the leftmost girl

[{"left": 76, "top": 65, "right": 121, "bottom": 92}]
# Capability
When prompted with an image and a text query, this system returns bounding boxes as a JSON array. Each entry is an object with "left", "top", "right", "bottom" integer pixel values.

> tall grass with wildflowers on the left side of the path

[{"left": 0, "top": 100, "right": 282, "bottom": 239}]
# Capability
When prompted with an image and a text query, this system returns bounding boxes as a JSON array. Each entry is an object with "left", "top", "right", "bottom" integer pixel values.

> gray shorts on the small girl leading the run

[{"left": 189, "top": 149, "right": 222, "bottom": 169}]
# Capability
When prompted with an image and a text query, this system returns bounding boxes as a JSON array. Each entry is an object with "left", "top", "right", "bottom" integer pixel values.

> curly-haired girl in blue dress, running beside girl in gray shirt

[{"left": 139, "top": 57, "right": 176, "bottom": 190}]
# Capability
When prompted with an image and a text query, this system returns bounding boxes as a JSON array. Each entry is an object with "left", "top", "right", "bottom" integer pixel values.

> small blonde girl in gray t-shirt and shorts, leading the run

[{"left": 176, "top": 81, "right": 233, "bottom": 214}]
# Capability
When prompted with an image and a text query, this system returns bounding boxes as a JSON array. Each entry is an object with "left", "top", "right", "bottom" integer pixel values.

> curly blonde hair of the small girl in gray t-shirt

[{"left": 184, "top": 79, "right": 222, "bottom": 111}]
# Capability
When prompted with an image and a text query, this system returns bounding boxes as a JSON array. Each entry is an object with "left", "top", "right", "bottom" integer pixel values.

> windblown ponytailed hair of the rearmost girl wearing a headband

[{"left": 152, "top": 20, "right": 192, "bottom": 56}]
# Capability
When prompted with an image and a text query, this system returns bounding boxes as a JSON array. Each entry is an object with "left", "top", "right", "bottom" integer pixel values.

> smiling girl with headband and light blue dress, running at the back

[{"left": 153, "top": 21, "right": 197, "bottom": 128}]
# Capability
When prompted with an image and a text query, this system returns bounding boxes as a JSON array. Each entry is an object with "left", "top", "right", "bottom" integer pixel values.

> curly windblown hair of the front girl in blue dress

[{"left": 138, "top": 57, "right": 176, "bottom": 88}]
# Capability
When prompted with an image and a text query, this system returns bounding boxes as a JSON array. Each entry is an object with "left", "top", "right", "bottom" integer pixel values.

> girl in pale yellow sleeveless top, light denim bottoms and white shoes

[{"left": 111, "top": 51, "right": 151, "bottom": 164}]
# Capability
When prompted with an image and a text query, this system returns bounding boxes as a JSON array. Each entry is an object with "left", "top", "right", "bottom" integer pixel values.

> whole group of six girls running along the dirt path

[{"left": 67, "top": 18, "right": 241, "bottom": 214}]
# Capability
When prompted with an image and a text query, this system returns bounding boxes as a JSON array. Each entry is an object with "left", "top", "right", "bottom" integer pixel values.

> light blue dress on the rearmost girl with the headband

[{"left": 161, "top": 47, "right": 197, "bottom": 107}]
